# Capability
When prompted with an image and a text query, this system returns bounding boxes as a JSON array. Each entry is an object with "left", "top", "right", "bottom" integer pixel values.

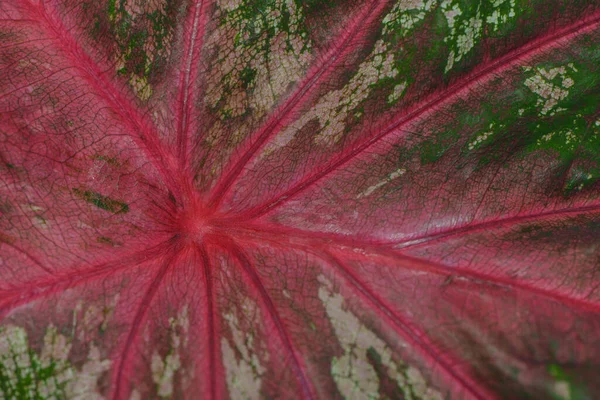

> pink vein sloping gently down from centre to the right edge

[{"left": 232, "top": 225, "right": 600, "bottom": 312}]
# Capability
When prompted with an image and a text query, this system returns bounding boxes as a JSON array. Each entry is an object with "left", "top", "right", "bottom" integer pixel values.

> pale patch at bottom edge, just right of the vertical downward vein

[{"left": 221, "top": 299, "right": 266, "bottom": 400}]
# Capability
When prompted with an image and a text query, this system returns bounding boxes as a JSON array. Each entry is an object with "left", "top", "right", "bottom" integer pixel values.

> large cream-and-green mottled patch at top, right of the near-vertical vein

[{"left": 206, "top": 0, "right": 311, "bottom": 120}]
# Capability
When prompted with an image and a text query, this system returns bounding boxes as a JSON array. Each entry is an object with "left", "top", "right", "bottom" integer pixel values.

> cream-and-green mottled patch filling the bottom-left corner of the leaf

[{"left": 0, "top": 325, "right": 110, "bottom": 400}]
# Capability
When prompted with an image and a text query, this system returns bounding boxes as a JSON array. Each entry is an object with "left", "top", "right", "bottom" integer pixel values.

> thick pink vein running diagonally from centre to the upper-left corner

[{"left": 26, "top": 0, "right": 179, "bottom": 194}]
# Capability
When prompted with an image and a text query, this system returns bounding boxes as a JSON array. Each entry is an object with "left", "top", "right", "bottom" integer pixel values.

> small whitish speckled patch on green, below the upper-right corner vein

[{"left": 524, "top": 64, "right": 577, "bottom": 115}]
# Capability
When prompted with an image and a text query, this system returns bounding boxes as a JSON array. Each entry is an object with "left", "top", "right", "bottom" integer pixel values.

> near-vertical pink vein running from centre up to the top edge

[{"left": 177, "top": 0, "right": 208, "bottom": 170}]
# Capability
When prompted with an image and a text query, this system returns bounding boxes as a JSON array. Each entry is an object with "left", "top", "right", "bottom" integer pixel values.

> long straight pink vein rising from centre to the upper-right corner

[{"left": 240, "top": 12, "right": 600, "bottom": 219}]
